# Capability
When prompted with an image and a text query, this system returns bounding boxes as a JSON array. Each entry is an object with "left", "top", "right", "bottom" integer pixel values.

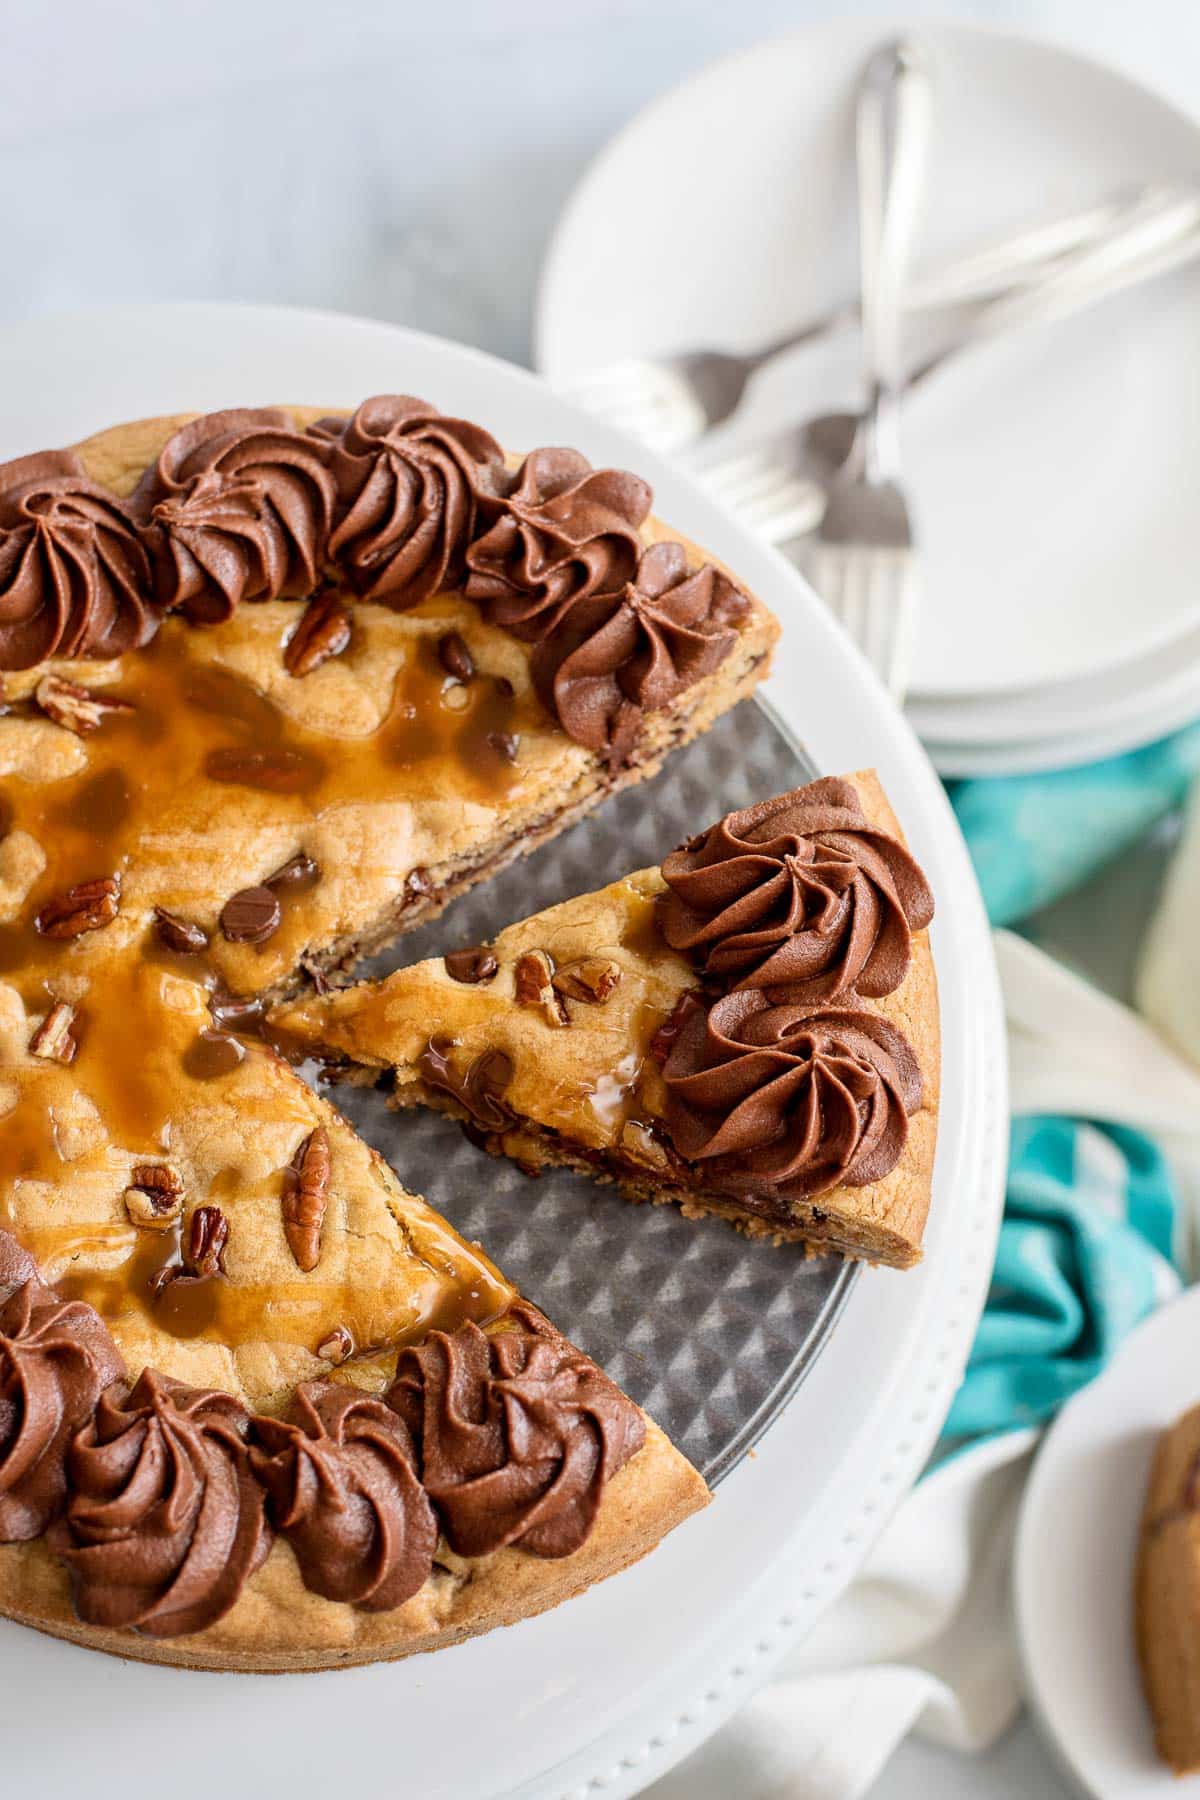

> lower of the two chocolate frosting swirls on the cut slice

[{"left": 662, "top": 988, "right": 921, "bottom": 1201}]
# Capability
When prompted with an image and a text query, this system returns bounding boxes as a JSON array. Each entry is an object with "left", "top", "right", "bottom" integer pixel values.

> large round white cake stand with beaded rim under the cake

[{"left": 0, "top": 306, "right": 1007, "bottom": 1800}]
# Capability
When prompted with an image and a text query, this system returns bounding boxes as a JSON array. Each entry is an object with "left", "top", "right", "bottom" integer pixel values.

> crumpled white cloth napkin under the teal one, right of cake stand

[{"left": 649, "top": 936, "right": 1200, "bottom": 1800}]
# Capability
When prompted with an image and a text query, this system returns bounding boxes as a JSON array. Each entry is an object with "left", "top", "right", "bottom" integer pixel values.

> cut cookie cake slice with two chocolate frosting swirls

[{"left": 272, "top": 774, "right": 939, "bottom": 1267}]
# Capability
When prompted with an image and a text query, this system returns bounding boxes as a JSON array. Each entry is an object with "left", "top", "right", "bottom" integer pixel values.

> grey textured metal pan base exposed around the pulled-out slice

[{"left": 335, "top": 702, "right": 858, "bottom": 1483}]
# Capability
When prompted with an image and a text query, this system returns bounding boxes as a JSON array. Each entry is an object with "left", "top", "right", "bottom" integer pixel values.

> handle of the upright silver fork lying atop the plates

[{"left": 856, "top": 38, "right": 932, "bottom": 457}]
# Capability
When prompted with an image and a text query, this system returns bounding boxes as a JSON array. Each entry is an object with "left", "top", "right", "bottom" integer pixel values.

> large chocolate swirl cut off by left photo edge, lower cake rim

[{"left": 0, "top": 1231, "right": 124, "bottom": 1544}]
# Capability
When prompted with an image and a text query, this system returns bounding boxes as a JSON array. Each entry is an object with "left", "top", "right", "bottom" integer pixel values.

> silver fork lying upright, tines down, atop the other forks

[{"left": 808, "top": 40, "right": 932, "bottom": 697}]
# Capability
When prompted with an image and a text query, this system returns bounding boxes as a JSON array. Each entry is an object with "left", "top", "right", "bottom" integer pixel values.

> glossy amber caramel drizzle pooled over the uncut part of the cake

[{"left": 0, "top": 599, "right": 528, "bottom": 1348}]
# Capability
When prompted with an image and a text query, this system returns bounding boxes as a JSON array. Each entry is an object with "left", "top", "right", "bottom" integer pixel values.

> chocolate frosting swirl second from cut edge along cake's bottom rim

[{"left": 250, "top": 1381, "right": 437, "bottom": 1613}]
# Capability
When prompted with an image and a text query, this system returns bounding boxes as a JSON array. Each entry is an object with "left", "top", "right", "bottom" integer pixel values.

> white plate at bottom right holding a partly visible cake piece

[{"left": 1015, "top": 1289, "right": 1200, "bottom": 1800}]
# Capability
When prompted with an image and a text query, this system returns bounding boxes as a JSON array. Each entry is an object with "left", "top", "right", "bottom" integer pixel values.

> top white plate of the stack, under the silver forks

[{"left": 536, "top": 20, "right": 1200, "bottom": 709}]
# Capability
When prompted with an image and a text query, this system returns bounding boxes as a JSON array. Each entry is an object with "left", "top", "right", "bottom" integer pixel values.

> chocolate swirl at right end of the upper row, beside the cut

[{"left": 533, "top": 544, "right": 748, "bottom": 765}]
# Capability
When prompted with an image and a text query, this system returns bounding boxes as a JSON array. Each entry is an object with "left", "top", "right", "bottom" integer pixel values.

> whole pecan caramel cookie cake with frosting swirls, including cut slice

[{"left": 0, "top": 396, "right": 937, "bottom": 1670}]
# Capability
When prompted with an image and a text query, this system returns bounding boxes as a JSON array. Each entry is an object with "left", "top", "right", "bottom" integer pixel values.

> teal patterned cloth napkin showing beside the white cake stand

[{"left": 939, "top": 724, "right": 1200, "bottom": 1454}]
